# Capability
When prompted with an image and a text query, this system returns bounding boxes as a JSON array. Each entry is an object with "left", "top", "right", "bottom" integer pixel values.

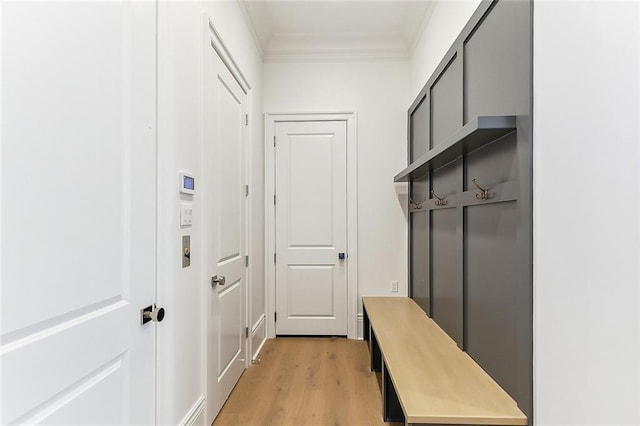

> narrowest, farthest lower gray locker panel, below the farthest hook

[{"left": 409, "top": 211, "right": 431, "bottom": 316}]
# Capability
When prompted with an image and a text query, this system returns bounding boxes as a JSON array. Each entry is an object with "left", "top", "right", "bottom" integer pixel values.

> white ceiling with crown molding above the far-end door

[{"left": 238, "top": 0, "right": 436, "bottom": 62}]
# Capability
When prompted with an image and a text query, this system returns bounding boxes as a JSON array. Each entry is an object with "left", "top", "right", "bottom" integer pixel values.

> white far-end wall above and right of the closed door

[{"left": 264, "top": 61, "right": 409, "bottom": 332}]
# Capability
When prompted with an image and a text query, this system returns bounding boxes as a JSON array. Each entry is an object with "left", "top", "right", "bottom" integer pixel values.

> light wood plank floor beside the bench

[{"left": 213, "top": 337, "right": 400, "bottom": 426}]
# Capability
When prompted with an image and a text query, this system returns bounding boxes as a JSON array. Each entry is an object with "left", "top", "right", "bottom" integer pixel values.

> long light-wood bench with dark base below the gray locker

[{"left": 362, "top": 297, "right": 527, "bottom": 425}]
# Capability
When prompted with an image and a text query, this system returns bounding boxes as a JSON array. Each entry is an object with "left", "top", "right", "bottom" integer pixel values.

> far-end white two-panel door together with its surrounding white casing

[{"left": 266, "top": 113, "right": 357, "bottom": 338}]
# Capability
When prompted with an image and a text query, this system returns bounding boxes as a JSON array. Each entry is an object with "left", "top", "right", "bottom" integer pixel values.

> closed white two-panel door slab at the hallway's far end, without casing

[{"left": 275, "top": 121, "right": 348, "bottom": 335}]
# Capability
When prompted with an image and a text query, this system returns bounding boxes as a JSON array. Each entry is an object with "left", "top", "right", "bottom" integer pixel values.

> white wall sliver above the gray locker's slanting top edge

[{"left": 409, "top": 0, "right": 480, "bottom": 98}]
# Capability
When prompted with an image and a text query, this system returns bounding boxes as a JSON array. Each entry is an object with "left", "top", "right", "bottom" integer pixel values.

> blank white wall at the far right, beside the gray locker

[{"left": 533, "top": 2, "right": 640, "bottom": 425}]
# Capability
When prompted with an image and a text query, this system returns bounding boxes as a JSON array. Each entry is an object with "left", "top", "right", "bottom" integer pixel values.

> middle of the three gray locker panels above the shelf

[{"left": 430, "top": 56, "right": 462, "bottom": 148}]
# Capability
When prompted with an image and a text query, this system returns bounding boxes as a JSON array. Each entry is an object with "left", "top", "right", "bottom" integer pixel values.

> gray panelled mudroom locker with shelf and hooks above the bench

[{"left": 395, "top": 0, "right": 533, "bottom": 424}]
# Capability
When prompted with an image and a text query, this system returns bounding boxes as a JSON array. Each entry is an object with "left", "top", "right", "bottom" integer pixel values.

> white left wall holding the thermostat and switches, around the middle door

[{"left": 157, "top": 2, "right": 264, "bottom": 424}]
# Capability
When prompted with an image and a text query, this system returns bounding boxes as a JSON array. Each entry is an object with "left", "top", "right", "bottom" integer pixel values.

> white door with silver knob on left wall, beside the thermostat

[{"left": 202, "top": 24, "right": 247, "bottom": 424}]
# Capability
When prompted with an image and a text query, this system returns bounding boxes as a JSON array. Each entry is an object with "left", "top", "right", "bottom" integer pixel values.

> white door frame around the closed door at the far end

[{"left": 264, "top": 112, "right": 358, "bottom": 339}]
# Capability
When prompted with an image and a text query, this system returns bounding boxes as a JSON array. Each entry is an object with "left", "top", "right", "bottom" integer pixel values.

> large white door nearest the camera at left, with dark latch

[{"left": 0, "top": 2, "right": 161, "bottom": 425}]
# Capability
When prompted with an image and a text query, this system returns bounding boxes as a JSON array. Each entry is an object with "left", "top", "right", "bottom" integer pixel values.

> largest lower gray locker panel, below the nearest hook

[{"left": 464, "top": 201, "right": 520, "bottom": 398}]
